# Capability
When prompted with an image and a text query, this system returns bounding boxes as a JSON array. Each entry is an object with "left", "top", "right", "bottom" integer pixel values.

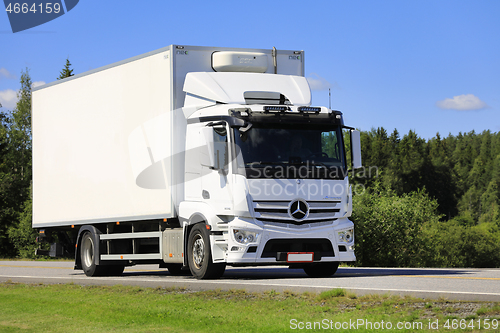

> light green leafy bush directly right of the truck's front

[{"left": 352, "top": 183, "right": 440, "bottom": 267}]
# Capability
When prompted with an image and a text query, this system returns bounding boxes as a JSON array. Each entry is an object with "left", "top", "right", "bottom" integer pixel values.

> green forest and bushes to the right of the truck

[{"left": 351, "top": 128, "right": 500, "bottom": 267}]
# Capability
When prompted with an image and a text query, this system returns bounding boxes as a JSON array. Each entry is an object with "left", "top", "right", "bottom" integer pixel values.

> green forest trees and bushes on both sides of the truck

[{"left": 0, "top": 65, "right": 500, "bottom": 267}]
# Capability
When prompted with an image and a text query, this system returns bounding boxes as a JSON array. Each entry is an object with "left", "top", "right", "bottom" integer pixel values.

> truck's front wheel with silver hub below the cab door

[{"left": 187, "top": 223, "right": 226, "bottom": 280}]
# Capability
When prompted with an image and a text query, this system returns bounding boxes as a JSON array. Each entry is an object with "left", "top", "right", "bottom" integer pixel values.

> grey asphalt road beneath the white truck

[{"left": 0, "top": 261, "right": 500, "bottom": 302}]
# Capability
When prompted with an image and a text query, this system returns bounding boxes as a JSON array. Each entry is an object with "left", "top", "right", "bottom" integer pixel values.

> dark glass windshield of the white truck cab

[{"left": 234, "top": 124, "right": 347, "bottom": 179}]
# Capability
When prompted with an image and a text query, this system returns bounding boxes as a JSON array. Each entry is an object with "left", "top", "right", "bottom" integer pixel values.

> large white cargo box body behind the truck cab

[{"left": 32, "top": 45, "right": 304, "bottom": 228}]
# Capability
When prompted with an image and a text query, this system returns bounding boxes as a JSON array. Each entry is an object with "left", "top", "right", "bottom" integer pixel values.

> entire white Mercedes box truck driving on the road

[{"left": 32, "top": 45, "right": 361, "bottom": 279}]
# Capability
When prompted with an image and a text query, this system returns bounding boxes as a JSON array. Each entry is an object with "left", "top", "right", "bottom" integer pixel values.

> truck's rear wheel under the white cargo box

[{"left": 80, "top": 231, "right": 125, "bottom": 276}]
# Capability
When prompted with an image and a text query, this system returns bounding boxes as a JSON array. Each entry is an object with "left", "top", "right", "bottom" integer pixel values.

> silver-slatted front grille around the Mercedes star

[{"left": 253, "top": 201, "right": 341, "bottom": 225}]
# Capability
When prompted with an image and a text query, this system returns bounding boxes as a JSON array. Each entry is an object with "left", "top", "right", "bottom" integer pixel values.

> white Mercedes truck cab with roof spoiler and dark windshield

[{"left": 179, "top": 73, "right": 355, "bottom": 278}]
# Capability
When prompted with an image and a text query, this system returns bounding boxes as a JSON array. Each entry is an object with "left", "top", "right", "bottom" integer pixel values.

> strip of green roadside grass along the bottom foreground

[{"left": 0, "top": 283, "right": 500, "bottom": 333}]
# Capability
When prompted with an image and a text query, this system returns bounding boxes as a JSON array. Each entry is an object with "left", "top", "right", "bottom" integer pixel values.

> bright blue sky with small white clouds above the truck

[{"left": 0, "top": 0, "right": 500, "bottom": 139}]
